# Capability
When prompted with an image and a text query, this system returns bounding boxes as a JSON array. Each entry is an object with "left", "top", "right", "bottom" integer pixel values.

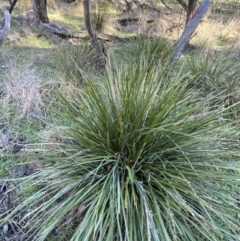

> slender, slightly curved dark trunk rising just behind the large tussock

[{"left": 83, "top": 0, "right": 107, "bottom": 65}]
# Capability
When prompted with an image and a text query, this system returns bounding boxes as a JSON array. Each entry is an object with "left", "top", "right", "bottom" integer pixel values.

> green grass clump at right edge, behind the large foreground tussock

[{"left": 185, "top": 53, "right": 240, "bottom": 117}]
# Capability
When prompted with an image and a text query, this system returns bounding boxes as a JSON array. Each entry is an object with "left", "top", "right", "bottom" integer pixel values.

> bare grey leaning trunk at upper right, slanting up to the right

[{"left": 173, "top": 0, "right": 210, "bottom": 62}]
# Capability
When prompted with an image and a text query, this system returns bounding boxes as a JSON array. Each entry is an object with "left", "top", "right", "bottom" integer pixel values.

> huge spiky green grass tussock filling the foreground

[{"left": 0, "top": 46, "right": 240, "bottom": 241}]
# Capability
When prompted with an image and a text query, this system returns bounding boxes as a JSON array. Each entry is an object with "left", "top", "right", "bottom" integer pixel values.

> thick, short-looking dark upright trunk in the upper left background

[{"left": 32, "top": 0, "right": 49, "bottom": 25}]
